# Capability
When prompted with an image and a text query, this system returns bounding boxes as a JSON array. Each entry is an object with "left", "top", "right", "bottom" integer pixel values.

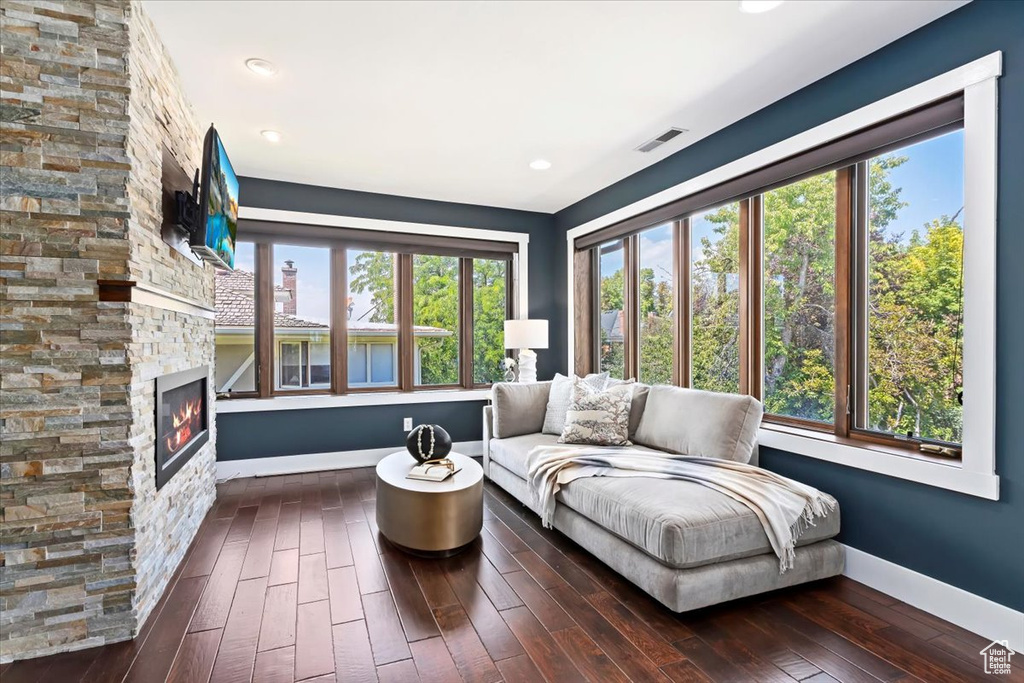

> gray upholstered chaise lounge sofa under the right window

[{"left": 483, "top": 382, "right": 844, "bottom": 612}]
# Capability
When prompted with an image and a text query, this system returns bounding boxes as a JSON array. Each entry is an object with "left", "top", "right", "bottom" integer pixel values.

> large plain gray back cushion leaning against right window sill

[{"left": 636, "top": 384, "right": 763, "bottom": 463}]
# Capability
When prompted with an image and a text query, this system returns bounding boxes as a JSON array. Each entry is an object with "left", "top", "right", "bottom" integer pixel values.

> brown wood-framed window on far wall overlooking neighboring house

[{"left": 216, "top": 232, "right": 516, "bottom": 397}]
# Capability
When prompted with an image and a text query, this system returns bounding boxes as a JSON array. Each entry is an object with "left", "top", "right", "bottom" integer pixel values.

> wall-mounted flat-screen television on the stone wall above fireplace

[{"left": 189, "top": 126, "right": 239, "bottom": 270}]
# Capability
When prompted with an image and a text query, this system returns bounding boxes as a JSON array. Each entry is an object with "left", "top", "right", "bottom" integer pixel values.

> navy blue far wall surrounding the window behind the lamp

[{"left": 217, "top": 177, "right": 566, "bottom": 460}]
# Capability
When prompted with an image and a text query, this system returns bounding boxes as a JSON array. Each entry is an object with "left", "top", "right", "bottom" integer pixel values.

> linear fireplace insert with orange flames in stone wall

[{"left": 157, "top": 366, "right": 210, "bottom": 489}]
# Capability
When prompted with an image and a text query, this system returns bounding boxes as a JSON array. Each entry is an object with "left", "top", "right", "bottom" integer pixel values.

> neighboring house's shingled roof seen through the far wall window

[{"left": 214, "top": 270, "right": 452, "bottom": 337}]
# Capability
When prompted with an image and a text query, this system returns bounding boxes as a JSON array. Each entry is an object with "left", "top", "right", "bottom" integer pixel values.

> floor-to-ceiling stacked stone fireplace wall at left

[{"left": 0, "top": 0, "right": 216, "bottom": 664}]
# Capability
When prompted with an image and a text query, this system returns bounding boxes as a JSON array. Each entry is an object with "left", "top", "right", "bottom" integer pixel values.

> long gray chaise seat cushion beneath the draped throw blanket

[{"left": 552, "top": 475, "right": 840, "bottom": 568}]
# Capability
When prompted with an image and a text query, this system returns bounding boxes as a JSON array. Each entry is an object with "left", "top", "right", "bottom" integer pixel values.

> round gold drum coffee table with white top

[{"left": 377, "top": 451, "right": 483, "bottom": 556}]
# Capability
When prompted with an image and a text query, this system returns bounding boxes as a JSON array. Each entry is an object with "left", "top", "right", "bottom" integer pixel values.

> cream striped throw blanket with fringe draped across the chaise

[{"left": 527, "top": 445, "right": 836, "bottom": 572}]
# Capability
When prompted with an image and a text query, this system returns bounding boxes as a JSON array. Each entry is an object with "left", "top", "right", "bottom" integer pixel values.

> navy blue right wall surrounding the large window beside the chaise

[{"left": 556, "top": 0, "right": 1024, "bottom": 610}]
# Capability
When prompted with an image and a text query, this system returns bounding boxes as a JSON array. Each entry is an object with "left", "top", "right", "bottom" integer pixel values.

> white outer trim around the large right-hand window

[{"left": 565, "top": 52, "right": 1002, "bottom": 501}]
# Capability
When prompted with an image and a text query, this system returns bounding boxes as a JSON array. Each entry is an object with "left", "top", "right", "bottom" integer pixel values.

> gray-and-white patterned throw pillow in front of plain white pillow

[{"left": 558, "top": 378, "right": 635, "bottom": 445}]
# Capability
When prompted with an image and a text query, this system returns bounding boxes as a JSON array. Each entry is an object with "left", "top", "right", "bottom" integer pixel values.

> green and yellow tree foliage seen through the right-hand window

[{"left": 601, "top": 155, "right": 964, "bottom": 442}]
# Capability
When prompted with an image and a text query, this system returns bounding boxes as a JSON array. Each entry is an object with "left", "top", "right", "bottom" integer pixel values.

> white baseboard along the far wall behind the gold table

[{"left": 217, "top": 441, "right": 483, "bottom": 481}]
